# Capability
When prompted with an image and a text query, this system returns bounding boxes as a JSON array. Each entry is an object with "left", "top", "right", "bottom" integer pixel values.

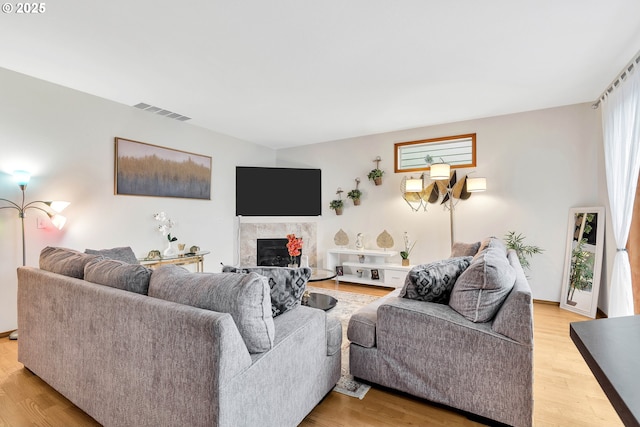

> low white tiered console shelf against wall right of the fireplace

[{"left": 327, "top": 249, "right": 412, "bottom": 288}]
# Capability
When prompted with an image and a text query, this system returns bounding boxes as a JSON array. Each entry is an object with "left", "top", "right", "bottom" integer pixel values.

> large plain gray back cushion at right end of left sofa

[{"left": 149, "top": 265, "right": 275, "bottom": 353}]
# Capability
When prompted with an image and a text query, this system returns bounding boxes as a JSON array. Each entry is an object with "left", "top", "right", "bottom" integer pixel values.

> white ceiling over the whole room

[{"left": 0, "top": 0, "right": 640, "bottom": 148}]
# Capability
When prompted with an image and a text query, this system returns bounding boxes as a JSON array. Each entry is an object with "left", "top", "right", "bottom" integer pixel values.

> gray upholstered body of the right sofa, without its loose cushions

[{"left": 347, "top": 251, "right": 533, "bottom": 427}]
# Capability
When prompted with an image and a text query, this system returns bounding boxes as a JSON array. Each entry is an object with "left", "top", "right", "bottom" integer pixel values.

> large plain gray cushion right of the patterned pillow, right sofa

[{"left": 449, "top": 246, "right": 516, "bottom": 322}]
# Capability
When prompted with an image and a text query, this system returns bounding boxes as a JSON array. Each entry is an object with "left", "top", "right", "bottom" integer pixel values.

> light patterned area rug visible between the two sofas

[{"left": 307, "top": 286, "right": 380, "bottom": 399}]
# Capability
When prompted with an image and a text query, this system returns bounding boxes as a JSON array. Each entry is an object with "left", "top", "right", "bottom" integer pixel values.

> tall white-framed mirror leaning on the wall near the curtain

[{"left": 560, "top": 207, "right": 605, "bottom": 318}]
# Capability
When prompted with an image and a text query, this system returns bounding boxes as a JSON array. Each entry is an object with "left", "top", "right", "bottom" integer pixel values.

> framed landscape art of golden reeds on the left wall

[{"left": 115, "top": 137, "right": 211, "bottom": 200}]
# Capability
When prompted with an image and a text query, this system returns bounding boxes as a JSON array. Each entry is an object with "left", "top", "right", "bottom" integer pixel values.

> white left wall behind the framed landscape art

[{"left": 0, "top": 69, "right": 275, "bottom": 332}]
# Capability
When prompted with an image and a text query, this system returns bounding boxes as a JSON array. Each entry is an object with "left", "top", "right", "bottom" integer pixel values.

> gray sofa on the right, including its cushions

[{"left": 347, "top": 239, "right": 533, "bottom": 427}]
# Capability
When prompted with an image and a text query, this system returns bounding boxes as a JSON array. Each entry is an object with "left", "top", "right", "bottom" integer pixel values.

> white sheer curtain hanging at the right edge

[{"left": 602, "top": 67, "right": 640, "bottom": 317}]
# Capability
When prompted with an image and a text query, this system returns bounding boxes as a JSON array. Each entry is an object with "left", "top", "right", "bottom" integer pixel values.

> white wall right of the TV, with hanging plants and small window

[{"left": 278, "top": 104, "right": 606, "bottom": 301}]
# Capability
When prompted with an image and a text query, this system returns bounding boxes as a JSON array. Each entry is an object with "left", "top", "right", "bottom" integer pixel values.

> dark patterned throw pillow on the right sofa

[{"left": 400, "top": 256, "right": 473, "bottom": 304}]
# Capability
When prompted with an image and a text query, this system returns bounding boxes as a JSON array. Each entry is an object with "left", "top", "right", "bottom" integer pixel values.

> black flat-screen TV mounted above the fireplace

[{"left": 236, "top": 166, "right": 322, "bottom": 216}]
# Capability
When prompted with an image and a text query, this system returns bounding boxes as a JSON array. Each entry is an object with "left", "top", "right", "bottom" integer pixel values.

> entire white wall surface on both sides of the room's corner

[{"left": 0, "top": 69, "right": 615, "bottom": 332}]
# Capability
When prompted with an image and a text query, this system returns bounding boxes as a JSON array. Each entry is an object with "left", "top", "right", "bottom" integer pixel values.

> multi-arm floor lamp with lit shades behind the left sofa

[{"left": 0, "top": 171, "right": 69, "bottom": 340}]
